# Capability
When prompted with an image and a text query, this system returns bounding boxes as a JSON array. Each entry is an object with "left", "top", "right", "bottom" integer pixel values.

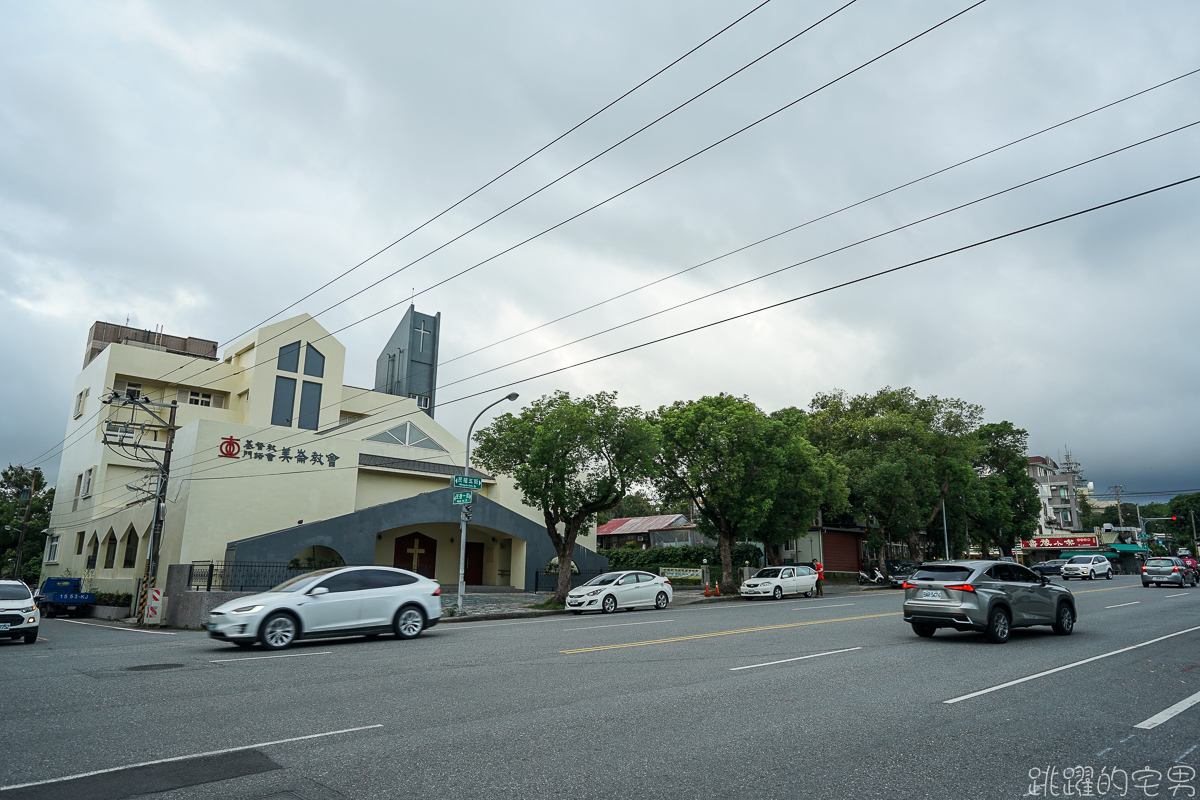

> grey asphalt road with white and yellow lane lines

[{"left": 0, "top": 577, "right": 1200, "bottom": 800}]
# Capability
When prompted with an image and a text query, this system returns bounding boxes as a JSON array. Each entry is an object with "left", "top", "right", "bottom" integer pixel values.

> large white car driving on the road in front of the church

[{"left": 208, "top": 566, "right": 442, "bottom": 650}]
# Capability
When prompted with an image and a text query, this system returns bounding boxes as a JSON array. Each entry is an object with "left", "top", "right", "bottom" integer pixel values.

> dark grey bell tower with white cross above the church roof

[{"left": 374, "top": 306, "right": 442, "bottom": 417}]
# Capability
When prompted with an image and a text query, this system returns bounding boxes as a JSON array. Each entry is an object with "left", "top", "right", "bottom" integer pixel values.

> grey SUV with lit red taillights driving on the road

[{"left": 904, "top": 560, "right": 1075, "bottom": 643}]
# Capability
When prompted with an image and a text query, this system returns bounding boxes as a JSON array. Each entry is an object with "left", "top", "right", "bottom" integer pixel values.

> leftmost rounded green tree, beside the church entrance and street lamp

[{"left": 473, "top": 391, "right": 658, "bottom": 603}]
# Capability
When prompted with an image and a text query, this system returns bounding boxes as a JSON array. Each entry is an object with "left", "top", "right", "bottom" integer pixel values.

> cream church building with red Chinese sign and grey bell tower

[{"left": 43, "top": 306, "right": 606, "bottom": 599}]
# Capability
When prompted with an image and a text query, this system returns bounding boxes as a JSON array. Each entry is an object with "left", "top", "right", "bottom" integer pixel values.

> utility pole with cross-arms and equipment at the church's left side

[{"left": 101, "top": 392, "right": 179, "bottom": 624}]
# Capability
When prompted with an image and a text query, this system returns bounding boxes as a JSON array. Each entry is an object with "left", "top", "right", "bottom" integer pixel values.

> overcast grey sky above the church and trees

[{"left": 0, "top": 0, "right": 1200, "bottom": 501}]
